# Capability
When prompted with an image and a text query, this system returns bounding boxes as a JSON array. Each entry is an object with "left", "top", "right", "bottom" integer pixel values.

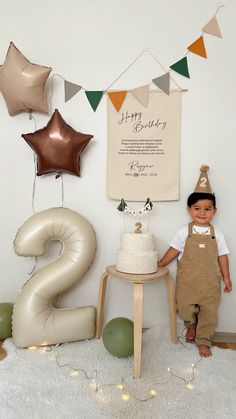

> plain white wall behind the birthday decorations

[{"left": 0, "top": 0, "right": 236, "bottom": 332}]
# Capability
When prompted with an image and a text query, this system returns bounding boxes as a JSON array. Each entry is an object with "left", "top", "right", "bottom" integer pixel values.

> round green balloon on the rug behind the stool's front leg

[{"left": 102, "top": 317, "right": 134, "bottom": 358}]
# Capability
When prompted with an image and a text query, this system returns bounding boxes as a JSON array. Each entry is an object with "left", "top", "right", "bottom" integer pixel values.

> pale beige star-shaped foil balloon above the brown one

[{"left": 0, "top": 42, "right": 52, "bottom": 116}]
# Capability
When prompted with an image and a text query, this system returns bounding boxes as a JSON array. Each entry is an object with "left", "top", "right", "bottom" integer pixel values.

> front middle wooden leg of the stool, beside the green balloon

[{"left": 134, "top": 284, "right": 143, "bottom": 378}]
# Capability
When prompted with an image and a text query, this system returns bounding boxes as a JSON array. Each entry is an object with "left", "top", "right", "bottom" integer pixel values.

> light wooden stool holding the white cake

[{"left": 96, "top": 265, "right": 177, "bottom": 378}]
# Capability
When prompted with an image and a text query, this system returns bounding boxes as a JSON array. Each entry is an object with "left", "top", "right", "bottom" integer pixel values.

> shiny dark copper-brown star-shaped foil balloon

[{"left": 22, "top": 109, "right": 93, "bottom": 176}]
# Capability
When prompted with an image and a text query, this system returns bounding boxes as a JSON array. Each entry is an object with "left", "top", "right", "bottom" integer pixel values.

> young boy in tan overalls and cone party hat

[{"left": 158, "top": 166, "right": 232, "bottom": 357}]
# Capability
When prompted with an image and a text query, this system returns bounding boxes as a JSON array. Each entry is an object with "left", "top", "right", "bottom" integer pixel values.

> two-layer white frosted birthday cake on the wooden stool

[{"left": 116, "top": 232, "right": 157, "bottom": 274}]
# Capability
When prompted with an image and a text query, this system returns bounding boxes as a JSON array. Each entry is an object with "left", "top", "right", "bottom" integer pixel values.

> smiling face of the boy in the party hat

[{"left": 188, "top": 199, "right": 217, "bottom": 227}]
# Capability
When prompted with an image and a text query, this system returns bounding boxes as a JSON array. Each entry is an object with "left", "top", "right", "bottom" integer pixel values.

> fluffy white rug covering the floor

[{"left": 0, "top": 325, "right": 236, "bottom": 419}]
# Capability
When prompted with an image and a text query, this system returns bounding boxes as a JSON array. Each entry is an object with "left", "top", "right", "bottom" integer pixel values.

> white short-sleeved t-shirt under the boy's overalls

[{"left": 168, "top": 224, "right": 230, "bottom": 260}]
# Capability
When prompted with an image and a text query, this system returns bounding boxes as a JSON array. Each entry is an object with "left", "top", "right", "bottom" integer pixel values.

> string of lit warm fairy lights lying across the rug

[{"left": 28, "top": 332, "right": 203, "bottom": 402}]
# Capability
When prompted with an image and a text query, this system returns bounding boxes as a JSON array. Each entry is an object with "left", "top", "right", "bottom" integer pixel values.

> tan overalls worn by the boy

[{"left": 176, "top": 223, "right": 222, "bottom": 347}]
